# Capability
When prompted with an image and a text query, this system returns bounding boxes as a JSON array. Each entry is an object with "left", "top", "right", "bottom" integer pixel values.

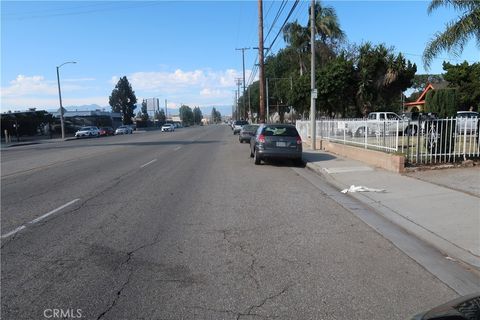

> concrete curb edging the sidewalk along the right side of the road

[{"left": 306, "top": 162, "right": 480, "bottom": 272}]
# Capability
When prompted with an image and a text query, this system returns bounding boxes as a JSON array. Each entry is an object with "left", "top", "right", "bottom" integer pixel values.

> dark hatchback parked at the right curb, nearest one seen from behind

[{"left": 250, "top": 124, "right": 303, "bottom": 166}]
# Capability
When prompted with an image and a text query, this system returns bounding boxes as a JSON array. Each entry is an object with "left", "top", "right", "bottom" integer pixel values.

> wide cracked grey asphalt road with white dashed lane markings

[{"left": 1, "top": 126, "right": 456, "bottom": 319}]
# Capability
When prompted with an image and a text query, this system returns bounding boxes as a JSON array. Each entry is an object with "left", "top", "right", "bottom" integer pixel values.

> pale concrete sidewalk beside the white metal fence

[{"left": 303, "top": 151, "right": 480, "bottom": 270}]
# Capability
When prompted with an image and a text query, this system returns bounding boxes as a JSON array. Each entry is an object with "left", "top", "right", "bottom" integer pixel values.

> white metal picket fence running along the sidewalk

[{"left": 296, "top": 118, "right": 480, "bottom": 164}]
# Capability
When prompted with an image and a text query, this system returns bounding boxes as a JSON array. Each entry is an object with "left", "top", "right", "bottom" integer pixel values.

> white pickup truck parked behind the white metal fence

[{"left": 348, "top": 112, "right": 409, "bottom": 137}]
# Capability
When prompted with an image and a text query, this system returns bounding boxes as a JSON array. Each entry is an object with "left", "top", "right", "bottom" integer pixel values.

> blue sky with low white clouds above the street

[{"left": 0, "top": 0, "right": 480, "bottom": 114}]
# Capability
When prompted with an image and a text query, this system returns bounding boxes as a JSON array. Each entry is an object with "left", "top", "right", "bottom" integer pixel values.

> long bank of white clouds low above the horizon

[{"left": 0, "top": 68, "right": 255, "bottom": 111}]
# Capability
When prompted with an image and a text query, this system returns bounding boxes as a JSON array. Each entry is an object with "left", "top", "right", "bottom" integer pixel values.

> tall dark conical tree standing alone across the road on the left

[{"left": 108, "top": 76, "right": 137, "bottom": 124}]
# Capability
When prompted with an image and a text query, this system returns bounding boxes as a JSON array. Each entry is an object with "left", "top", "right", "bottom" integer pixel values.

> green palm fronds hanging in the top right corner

[{"left": 423, "top": 0, "right": 480, "bottom": 68}]
